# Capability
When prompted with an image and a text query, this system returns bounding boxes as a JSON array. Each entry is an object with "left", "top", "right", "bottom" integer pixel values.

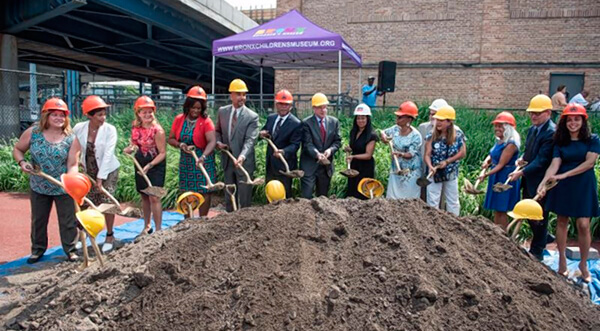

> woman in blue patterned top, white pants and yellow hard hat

[{"left": 425, "top": 106, "right": 467, "bottom": 216}]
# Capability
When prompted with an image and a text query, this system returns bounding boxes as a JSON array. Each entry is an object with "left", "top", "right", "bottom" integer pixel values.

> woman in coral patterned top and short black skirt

[{"left": 123, "top": 95, "right": 167, "bottom": 235}]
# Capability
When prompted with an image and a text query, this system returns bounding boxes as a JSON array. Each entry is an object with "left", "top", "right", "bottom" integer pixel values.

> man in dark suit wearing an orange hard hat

[{"left": 260, "top": 90, "right": 302, "bottom": 198}]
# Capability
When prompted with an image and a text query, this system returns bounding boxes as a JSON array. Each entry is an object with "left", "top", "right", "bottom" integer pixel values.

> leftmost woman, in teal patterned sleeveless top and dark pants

[{"left": 13, "top": 98, "right": 80, "bottom": 263}]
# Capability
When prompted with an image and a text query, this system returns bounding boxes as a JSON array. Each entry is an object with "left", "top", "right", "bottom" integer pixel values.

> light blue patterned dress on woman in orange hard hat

[{"left": 385, "top": 125, "right": 423, "bottom": 199}]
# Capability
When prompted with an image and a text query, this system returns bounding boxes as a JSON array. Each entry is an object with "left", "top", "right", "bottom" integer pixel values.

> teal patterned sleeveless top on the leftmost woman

[{"left": 29, "top": 126, "right": 75, "bottom": 196}]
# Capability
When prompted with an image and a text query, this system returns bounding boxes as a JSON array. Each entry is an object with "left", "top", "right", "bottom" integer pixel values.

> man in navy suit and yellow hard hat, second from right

[{"left": 511, "top": 94, "right": 556, "bottom": 261}]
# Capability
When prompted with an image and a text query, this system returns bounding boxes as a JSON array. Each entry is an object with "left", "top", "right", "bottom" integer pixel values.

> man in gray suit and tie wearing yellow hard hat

[{"left": 215, "top": 79, "right": 258, "bottom": 211}]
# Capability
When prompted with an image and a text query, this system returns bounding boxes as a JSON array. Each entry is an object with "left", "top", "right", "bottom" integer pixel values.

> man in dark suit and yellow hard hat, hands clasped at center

[{"left": 300, "top": 93, "right": 342, "bottom": 199}]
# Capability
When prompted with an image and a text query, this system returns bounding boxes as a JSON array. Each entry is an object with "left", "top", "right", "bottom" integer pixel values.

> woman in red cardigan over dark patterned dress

[{"left": 169, "top": 86, "right": 217, "bottom": 216}]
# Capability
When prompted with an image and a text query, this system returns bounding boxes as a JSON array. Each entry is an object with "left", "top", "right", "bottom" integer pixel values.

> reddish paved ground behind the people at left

[{"left": 0, "top": 192, "right": 215, "bottom": 264}]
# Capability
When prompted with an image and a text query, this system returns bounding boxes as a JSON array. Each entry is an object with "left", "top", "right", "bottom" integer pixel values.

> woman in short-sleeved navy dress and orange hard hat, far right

[{"left": 538, "top": 104, "right": 600, "bottom": 283}]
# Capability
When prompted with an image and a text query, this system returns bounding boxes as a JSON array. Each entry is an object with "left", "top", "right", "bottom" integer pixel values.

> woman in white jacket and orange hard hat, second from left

[{"left": 73, "top": 95, "right": 121, "bottom": 252}]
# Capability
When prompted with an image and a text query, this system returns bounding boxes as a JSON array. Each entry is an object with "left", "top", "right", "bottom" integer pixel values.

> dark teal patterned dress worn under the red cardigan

[{"left": 179, "top": 120, "right": 217, "bottom": 193}]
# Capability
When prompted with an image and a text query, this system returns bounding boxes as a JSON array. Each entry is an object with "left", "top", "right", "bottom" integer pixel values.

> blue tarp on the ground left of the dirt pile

[{"left": 0, "top": 211, "right": 183, "bottom": 276}]
